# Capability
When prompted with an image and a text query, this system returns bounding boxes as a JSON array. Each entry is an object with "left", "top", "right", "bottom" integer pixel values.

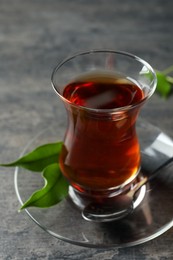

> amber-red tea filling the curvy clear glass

[{"left": 60, "top": 73, "right": 144, "bottom": 198}]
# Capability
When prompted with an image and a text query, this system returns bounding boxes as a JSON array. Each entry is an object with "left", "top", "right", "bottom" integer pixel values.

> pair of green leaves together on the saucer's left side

[{"left": 0, "top": 142, "right": 69, "bottom": 209}]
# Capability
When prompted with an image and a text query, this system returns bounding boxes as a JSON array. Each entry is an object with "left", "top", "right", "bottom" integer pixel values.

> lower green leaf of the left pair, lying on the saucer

[{"left": 21, "top": 163, "right": 69, "bottom": 209}]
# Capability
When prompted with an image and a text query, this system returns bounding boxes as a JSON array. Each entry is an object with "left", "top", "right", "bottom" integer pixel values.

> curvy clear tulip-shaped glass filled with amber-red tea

[{"left": 51, "top": 50, "right": 157, "bottom": 221}]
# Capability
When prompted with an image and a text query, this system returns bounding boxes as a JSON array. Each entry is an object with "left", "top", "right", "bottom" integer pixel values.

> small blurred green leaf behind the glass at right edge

[{"left": 156, "top": 71, "right": 171, "bottom": 98}]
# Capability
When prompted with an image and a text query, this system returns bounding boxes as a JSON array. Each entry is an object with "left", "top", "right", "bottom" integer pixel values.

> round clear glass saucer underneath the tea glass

[{"left": 14, "top": 119, "right": 173, "bottom": 248}]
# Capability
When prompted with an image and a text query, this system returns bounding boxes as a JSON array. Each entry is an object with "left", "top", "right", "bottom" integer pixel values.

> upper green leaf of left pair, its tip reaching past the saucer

[{"left": 0, "top": 142, "right": 62, "bottom": 172}]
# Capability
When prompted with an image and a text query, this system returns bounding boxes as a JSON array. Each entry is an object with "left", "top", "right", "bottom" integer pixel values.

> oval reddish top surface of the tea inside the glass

[{"left": 63, "top": 74, "right": 143, "bottom": 109}]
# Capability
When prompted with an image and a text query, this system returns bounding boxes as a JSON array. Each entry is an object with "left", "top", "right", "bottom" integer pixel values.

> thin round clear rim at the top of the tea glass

[{"left": 51, "top": 49, "right": 157, "bottom": 113}]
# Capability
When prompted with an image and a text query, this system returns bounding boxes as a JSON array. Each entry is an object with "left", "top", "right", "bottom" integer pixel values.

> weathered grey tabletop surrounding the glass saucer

[{"left": 0, "top": 0, "right": 173, "bottom": 260}]
